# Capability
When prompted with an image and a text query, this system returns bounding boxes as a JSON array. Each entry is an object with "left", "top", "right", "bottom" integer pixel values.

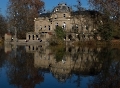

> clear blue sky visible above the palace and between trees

[{"left": 0, "top": 0, "right": 89, "bottom": 16}]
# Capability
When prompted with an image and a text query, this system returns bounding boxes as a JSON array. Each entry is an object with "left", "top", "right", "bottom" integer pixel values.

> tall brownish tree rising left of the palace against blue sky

[{"left": 7, "top": 0, "right": 44, "bottom": 38}]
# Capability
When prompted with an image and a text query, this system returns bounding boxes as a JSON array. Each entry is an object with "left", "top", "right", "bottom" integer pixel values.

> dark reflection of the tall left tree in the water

[{"left": 7, "top": 47, "right": 44, "bottom": 88}]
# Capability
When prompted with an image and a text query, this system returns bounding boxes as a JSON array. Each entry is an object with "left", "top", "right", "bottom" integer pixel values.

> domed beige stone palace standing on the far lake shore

[{"left": 26, "top": 4, "right": 102, "bottom": 41}]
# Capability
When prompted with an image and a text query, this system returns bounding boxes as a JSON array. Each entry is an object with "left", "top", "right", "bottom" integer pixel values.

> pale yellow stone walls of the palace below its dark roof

[{"left": 32, "top": 4, "right": 100, "bottom": 41}]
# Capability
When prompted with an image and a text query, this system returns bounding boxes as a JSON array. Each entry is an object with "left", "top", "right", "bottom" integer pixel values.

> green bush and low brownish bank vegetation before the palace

[{"left": 49, "top": 25, "right": 120, "bottom": 47}]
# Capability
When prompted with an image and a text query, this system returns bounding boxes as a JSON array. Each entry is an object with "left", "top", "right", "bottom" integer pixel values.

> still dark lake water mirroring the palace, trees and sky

[{"left": 0, "top": 45, "right": 120, "bottom": 88}]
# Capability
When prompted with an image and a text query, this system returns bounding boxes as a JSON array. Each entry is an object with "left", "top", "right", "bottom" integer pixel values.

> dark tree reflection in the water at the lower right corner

[{"left": 90, "top": 48, "right": 120, "bottom": 88}]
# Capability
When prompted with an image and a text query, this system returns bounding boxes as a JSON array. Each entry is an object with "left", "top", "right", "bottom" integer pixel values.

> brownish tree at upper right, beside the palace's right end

[{"left": 88, "top": 0, "right": 120, "bottom": 39}]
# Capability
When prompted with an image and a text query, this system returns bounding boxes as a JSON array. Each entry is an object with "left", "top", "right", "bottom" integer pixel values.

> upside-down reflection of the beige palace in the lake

[{"left": 26, "top": 46, "right": 101, "bottom": 81}]
